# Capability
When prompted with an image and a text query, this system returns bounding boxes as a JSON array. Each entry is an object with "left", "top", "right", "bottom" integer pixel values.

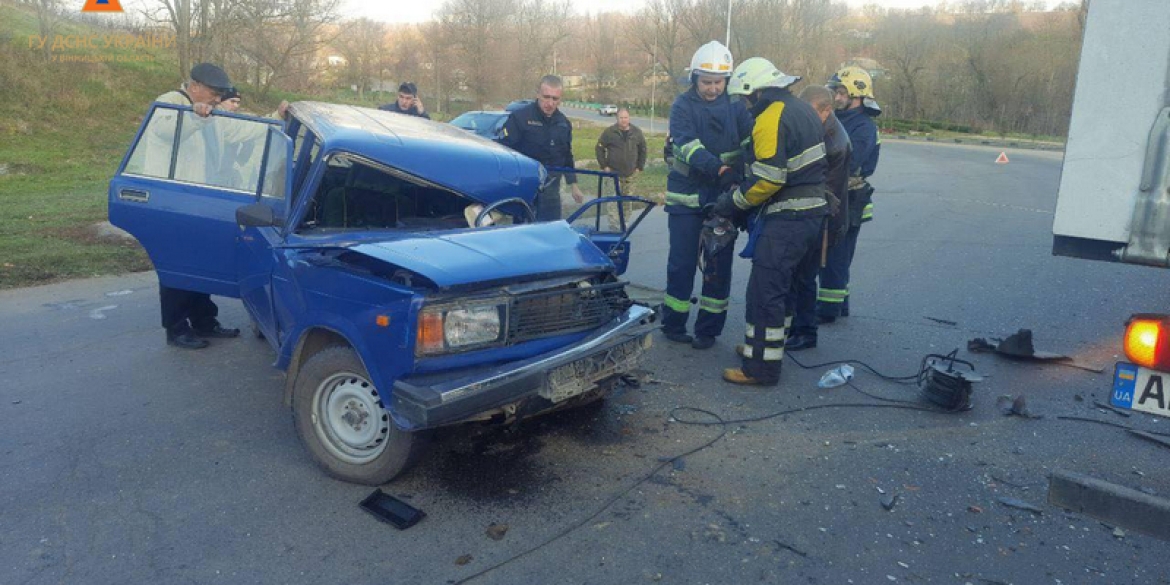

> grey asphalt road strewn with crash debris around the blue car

[{"left": 0, "top": 142, "right": 1170, "bottom": 585}]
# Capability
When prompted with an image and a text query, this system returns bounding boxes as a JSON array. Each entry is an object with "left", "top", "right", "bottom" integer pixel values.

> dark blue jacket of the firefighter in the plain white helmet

[{"left": 666, "top": 85, "right": 751, "bottom": 213}]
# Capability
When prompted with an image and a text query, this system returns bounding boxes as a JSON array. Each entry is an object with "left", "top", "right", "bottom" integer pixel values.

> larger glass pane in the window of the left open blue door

[{"left": 174, "top": 111, "right": 269, "bottom": 193}]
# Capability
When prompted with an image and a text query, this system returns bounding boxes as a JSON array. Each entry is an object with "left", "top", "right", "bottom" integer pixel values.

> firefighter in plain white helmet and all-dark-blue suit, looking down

[{"left": 662, "top": 41, "right": 751, "bottom": 350}]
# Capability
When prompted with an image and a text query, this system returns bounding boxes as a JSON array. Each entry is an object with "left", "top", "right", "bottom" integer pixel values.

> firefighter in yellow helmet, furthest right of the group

[{"left": 817, "top": 67, "right": 881, "bottom": 323}]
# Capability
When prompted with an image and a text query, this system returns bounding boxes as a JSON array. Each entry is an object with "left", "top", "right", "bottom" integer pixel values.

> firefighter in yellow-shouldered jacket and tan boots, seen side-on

[{"left": 714, "top": 57, "right": 830, "bottom": 386}]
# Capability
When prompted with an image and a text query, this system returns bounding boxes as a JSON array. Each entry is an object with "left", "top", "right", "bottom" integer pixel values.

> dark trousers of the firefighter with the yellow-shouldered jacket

[{"left": 743, "top": 213, "right": 824, "bottom": 384}]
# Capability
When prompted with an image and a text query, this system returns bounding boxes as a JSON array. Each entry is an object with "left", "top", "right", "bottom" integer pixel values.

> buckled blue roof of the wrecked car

[{"left": 290, "top": 102, "right": 541, "bottom": 202}]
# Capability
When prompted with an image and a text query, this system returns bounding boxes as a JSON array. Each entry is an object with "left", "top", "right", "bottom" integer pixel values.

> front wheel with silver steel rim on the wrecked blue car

[{"left": 293, "top": 346, "right": 422, "bottom": 486}]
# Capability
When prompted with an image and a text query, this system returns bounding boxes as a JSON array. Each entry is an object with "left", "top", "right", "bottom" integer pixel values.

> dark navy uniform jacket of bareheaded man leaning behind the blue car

[{"left": 500, "top": 102, "right": 577, "bottom": 185}]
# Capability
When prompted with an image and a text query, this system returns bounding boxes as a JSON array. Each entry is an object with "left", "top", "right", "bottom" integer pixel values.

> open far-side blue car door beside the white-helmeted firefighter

[{"left": 559, "top": 167, "right": 658, "bottom": 275}]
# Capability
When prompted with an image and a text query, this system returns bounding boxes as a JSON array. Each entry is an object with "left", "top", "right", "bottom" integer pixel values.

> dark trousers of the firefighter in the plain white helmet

[{"left": 662, "top": 213, "right": 735, "bottom": 337}]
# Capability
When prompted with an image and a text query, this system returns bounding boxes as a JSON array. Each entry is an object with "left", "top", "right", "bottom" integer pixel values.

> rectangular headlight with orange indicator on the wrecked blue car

[{"left": 415, "top": 304, "right": 507, "bottom": 356}]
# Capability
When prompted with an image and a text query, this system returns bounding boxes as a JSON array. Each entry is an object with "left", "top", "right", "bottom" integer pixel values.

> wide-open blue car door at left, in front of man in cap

[{"left": 109, "top": 103, "right": 288, "bottom": 297}]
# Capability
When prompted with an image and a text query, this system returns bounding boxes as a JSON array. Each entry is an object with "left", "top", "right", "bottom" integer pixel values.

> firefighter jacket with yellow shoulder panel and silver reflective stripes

[{"left": 734, "top": 88, "right": 828, "bottom": 213}]
